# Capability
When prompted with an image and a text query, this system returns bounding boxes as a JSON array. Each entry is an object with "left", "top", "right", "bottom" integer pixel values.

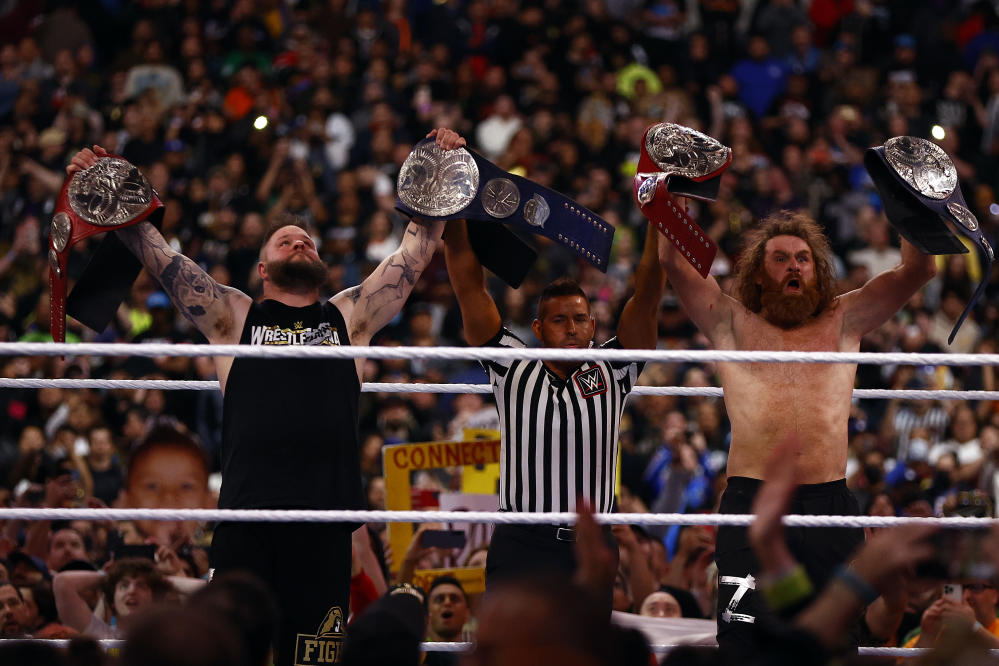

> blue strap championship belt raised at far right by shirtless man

[{"left": 864, "top": 136, "right": 995, "bottom": 344}]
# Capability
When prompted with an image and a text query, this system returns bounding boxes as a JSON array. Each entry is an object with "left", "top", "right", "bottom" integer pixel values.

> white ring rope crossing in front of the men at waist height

[{"left": 0, "top": 508, "right": 999, "bottom": 529}]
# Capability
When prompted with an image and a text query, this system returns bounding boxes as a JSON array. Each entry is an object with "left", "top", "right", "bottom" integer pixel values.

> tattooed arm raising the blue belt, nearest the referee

[{"left": 330, "top": 219, "right": 444, "bottom": 345}]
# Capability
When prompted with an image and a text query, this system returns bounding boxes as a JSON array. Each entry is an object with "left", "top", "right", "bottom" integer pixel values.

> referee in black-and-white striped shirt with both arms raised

[{"left": 444, "top": 220, "right": 666, "bottom": 613}]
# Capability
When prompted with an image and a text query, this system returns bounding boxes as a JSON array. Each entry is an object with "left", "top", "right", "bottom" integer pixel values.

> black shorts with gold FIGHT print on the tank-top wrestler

[{"left": 212, "top": 523, "right": 353, "bottom": 666}]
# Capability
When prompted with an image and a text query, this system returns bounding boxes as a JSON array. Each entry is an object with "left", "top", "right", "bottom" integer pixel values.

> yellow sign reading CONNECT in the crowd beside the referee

[{"left": 382, "top": 430, "right": 500, "bottom": 573}]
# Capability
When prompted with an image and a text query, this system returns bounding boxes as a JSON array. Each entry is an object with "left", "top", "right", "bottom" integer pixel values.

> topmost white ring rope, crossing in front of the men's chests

[{"left": 0, "top": 342, "right": 999, "bottom": 366}]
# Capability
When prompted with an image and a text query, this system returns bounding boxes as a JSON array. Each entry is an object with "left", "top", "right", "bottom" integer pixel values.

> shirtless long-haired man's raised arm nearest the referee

[{"left": 659, "top": 227, "right": 736, "bottom": 347}]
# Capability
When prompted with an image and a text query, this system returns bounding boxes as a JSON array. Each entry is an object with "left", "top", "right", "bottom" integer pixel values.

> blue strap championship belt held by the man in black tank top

[{"left": 395, "top": 139, "right": 614, "bottom": 287}]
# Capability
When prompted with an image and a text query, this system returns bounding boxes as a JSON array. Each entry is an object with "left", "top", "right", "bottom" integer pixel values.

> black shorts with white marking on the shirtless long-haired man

[{"left": 715, "top": 476, "right": 864, "bottom": 663}]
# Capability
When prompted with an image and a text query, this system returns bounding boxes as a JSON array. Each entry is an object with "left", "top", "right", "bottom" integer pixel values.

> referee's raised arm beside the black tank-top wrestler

[{"left": 444, "top": 220, "right": 503, "bottom": 347}]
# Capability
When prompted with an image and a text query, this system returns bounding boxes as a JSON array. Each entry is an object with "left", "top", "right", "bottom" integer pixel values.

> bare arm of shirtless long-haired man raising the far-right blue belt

[{"left": 841, "top": 238, "right": 937, "bottom": 339}]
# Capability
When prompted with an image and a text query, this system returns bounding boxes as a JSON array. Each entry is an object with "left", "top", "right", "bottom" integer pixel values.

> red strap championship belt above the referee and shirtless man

[{"left": 634, "top": 123, "right": 732, "bottom": 277}]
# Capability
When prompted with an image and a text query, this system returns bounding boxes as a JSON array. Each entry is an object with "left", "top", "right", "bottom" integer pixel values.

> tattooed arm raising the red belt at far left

[{"left": 115, "top": 222, "right": 250, "bottom": 344}]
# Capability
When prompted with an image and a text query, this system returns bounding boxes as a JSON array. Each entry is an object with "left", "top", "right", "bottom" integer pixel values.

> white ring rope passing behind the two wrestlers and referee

[{"left": 0, "top": 377, "right": 999, "bottom": 400}]
